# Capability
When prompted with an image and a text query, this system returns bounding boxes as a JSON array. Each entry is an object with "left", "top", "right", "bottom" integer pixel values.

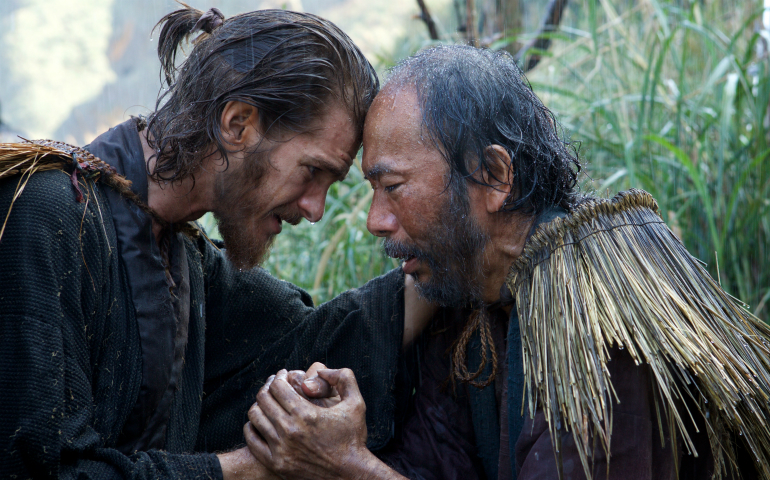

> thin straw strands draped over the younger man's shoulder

[{"left": 0, "top": 139, "right": 200, "bottom": 240}]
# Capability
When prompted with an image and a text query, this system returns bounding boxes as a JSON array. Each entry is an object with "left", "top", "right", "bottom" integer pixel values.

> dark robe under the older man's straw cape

[{"left": 378, "top": 209, "right": 720, "bottom": 480}]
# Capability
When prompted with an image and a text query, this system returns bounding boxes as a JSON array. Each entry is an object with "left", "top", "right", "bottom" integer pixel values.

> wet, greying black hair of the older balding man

[{"left": 385, "top": 45, "right": 581, "bottom": 215}]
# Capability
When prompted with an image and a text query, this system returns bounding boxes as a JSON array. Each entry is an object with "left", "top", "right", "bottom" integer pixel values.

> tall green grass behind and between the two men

[{"left": 201, "top": 0, "right": 770, "bottom": 319}]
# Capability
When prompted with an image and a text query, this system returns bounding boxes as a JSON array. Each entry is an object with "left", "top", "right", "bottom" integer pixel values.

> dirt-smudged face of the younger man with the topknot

[{"left": 214, "top": 103, "right": 358, "bottom": 268}]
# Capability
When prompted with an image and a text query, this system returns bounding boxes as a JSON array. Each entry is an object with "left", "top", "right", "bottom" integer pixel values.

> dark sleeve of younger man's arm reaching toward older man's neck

[{"left": 197, "top": 239, "right": 404, "bottom": 451}]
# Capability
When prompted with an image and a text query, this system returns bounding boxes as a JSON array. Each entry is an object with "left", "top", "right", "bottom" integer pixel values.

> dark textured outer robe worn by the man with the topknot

[{"left": 0, "top": 142, "right": 403, "bottom": 479}]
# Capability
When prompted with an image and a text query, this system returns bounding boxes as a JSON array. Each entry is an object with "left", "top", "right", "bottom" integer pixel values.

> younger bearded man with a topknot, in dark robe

[{"left": 0, "top": 8, "right": 432, "bottom": 479}]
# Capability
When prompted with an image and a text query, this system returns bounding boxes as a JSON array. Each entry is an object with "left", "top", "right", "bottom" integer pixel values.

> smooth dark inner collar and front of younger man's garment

[{"left": 85, "top": 120, "right": 190, "bottom": 454}]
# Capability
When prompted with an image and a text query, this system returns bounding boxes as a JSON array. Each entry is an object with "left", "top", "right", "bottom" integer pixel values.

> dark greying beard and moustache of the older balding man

[{"left": 383, "top": 179, "right": 489, "bottom": 307}]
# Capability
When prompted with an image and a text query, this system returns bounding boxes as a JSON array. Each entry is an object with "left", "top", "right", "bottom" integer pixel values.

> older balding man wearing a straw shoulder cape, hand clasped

[{"left": 245, "top": 46, "right": 770, "bottom": 480}]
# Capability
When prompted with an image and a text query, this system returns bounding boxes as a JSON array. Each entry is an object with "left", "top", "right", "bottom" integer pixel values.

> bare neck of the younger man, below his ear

[{"left": 139, "top": 129, "right": 214, "bottom": 240}]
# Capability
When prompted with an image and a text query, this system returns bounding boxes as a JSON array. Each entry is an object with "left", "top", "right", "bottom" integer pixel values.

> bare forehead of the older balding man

[{"left": 363, "top": 88, "right": 447, "bottom": 173}]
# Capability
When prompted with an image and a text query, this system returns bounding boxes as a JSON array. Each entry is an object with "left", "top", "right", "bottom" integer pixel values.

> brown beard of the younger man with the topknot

[{"left": 212, "top": 152, "right": 303, "bottom": 270}]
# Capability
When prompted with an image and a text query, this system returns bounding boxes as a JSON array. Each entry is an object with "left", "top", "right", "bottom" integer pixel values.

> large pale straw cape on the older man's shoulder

[{"left": 506, "top": 190, "right": 770, "bottom": 479}]
